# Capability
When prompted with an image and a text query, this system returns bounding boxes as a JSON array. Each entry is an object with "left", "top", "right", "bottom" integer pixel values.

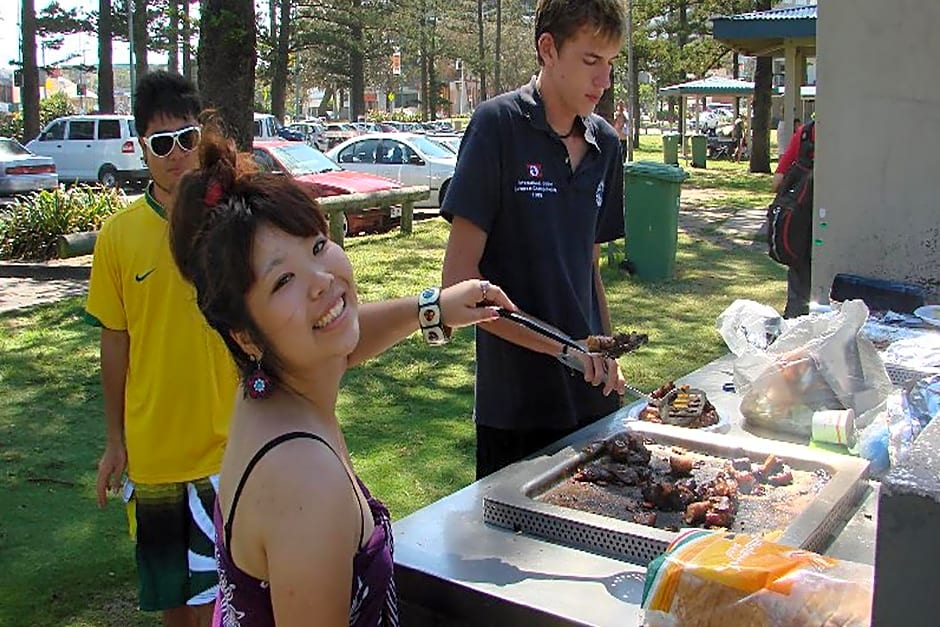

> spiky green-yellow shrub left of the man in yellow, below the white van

[{"left": 0, "top": 185, "right": 127, "bottom": 260}]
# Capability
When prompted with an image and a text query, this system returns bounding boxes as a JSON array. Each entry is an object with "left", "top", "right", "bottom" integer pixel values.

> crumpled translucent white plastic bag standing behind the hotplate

[{"left": 722, "top": 300, "right": 892, "bottom": 438}]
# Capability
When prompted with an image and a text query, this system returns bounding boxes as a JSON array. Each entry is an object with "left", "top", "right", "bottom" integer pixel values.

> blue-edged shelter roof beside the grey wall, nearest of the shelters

[{"left": 712, "top": 5, "right": 816, "bottom": 56}]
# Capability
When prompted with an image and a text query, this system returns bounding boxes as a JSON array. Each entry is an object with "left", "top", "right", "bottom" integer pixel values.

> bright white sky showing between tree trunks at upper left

[{"left": 0, "top": 0, "right": 166, "bottom": 70}]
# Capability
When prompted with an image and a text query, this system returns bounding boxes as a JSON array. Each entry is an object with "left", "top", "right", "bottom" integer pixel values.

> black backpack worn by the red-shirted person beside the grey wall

[{"left": 767, "top": 122, "right": 815, "bottom": 266}]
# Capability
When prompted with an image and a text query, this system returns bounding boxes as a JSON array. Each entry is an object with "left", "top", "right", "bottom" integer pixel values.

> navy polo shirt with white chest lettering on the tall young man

[{"left": 441, "top": 78, "right": 623, "bottom": 429}]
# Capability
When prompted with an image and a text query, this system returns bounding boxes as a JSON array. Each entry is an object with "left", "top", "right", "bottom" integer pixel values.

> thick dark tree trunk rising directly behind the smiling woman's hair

[{"left": 199, "top": 0, "right": 257, "bottom": 150}]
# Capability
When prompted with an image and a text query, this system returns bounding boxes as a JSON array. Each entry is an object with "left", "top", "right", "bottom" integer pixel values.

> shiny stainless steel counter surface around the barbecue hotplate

[{"left": 394, "top": 355, "right": 878, "bottom": 627}]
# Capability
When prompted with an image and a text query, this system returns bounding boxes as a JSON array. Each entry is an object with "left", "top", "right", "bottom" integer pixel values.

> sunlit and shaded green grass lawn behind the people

[{"left": 0, "top": 152, "right": 786, "bottom": 627}]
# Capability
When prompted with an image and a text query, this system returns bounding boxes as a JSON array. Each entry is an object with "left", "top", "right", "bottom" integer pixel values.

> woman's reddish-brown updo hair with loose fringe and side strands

[{"left": 170, "top": 110, "right": 329, "bottom": 385}]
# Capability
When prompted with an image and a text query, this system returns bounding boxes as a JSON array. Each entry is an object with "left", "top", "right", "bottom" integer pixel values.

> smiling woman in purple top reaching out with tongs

[{"left": 170, "top": 124, "right": 514, "bottom": 626}]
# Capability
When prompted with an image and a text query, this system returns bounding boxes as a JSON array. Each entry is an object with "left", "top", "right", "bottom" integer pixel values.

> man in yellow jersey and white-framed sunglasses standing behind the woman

[{"left": 86, "top": 72, "right": 238, "bottom": 627}]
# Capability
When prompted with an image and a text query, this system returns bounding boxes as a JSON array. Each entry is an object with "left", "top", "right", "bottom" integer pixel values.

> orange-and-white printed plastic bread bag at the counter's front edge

[{"left": 643, "top": 529, "right": 874, "bottom": 627}]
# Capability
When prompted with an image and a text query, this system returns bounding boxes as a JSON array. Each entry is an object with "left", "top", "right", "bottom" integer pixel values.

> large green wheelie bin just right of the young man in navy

[{"left": 623, "top": 161, "right": 689, "bottom": 281}]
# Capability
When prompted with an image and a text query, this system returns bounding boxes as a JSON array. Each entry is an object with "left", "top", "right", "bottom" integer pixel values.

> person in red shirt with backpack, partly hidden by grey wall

[{"left": 767, "top": 122, "right": 816, "bottom": 318}]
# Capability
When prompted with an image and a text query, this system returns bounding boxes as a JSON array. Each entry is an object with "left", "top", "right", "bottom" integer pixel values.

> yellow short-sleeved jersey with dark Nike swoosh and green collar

[{"left": 85, "top": 191, "right": 238, "bottom": 483}]
